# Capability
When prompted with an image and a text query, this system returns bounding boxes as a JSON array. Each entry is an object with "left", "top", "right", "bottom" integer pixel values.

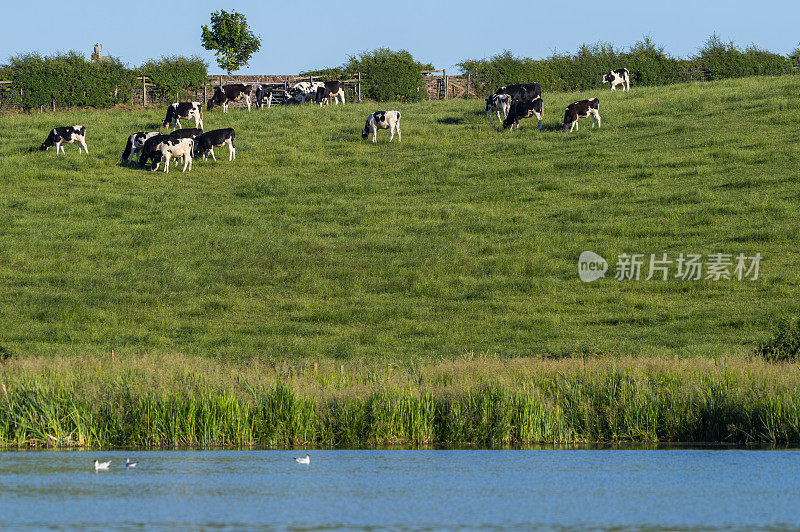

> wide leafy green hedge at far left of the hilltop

[{"left": 6, "top": 52, "right": 136, "bottom": 109}]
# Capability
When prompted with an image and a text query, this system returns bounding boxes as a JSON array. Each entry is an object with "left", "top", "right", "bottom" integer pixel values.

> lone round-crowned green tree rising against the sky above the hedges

[{"left": 201, "top": 9, "right": 261, "bottom": 74}]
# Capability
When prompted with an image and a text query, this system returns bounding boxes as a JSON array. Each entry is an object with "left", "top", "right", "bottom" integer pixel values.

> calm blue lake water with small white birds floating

[{"left": 0, "top": 449, "right": 800, "bottom": 531}]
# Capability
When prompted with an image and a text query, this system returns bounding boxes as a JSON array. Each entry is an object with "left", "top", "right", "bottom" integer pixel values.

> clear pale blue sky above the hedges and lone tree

[{"left": 0, "top": 0, "right": 800, "bottom": 74}]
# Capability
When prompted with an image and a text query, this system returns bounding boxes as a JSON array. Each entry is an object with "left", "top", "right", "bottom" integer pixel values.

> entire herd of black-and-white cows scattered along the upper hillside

[{"left": 40, "top": 68, "right": 630, "bottom": 162}]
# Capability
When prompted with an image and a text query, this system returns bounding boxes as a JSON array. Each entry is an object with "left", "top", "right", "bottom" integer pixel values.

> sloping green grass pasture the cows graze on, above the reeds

[{"left": 0, "top": 76, "right": 800, "bottom": 359}]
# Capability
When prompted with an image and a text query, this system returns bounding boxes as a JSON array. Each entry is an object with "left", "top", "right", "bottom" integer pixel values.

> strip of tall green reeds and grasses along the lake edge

[{"left": 0, "top": 354, "right": 800, "bottom": 447}]
